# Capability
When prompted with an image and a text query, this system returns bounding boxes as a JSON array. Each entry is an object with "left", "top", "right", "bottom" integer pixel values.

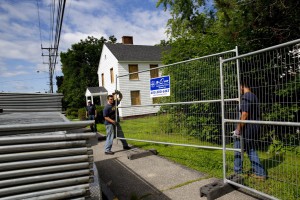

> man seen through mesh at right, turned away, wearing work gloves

[{"left": 234, "top": 83, "right": 266, "bottom": 180}]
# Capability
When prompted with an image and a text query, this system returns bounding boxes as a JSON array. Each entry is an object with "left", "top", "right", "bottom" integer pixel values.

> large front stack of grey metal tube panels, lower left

[{"left": 0, "top": 114, "right": 101, "bottom": 200}]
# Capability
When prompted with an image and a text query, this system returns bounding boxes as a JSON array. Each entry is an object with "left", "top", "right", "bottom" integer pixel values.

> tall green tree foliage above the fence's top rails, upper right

[{"left": 157, "top": 0, "right": 300, "bottom": 56}]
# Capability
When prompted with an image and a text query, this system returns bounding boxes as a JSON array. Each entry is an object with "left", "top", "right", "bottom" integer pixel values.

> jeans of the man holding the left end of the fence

[{"left": 104, "top": 124, "right": 128, "bottom": 152}]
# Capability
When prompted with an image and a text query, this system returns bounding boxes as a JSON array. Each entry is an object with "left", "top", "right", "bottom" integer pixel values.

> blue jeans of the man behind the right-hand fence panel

[{"left": 234, "top": 138, "right": 266, "bottom": 176}]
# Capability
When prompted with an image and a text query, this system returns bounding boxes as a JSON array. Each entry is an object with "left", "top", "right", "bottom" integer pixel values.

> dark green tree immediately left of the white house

[{"left": 58, "top": 36, "right": 116, "bottom": 108}]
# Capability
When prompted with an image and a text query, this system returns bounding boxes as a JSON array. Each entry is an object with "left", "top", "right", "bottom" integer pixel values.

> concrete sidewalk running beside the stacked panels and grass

[{"left": 93, "top": 135, "right": 258, "bottom": 200}]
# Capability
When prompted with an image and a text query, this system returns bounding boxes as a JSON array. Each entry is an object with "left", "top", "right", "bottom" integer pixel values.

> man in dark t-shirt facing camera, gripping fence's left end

[{"left": 103, "top": 91, "right": 130, "bottom": 155}]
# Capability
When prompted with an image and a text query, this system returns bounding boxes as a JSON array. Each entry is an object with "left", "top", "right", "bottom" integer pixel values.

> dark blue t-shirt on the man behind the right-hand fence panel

[{"left": 240, "top": 92, "right": 260, "bottom": 139}]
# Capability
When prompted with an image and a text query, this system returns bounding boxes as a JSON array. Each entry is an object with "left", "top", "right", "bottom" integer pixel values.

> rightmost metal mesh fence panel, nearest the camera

[{"left": 220, "top": 40, "right": 300, "bottom": 200}]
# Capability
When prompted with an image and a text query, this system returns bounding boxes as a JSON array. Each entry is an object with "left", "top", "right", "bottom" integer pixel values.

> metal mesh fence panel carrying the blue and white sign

[{"left": 116, "top": 49, "right": 237, "bottom": 149}]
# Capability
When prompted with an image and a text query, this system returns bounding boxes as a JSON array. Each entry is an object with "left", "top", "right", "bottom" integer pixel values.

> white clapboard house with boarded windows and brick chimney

[{"left": 98, "top": 36, "right": 168, "bottom": 117}]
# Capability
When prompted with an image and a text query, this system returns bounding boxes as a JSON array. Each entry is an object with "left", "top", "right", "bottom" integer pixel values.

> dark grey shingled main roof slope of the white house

[{"left": 105, "top": 43, "right": 169, "bottom": 62}]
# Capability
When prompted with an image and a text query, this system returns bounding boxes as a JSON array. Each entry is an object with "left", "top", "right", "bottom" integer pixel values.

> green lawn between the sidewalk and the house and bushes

[{"left": 97, "top": 117, "right": 300, "bottom": 200}]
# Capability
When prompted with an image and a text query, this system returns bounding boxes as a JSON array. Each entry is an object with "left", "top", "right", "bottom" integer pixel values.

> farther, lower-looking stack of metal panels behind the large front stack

[{"left": 0, "top": 93, "right": 63, "bottom": 113}]
